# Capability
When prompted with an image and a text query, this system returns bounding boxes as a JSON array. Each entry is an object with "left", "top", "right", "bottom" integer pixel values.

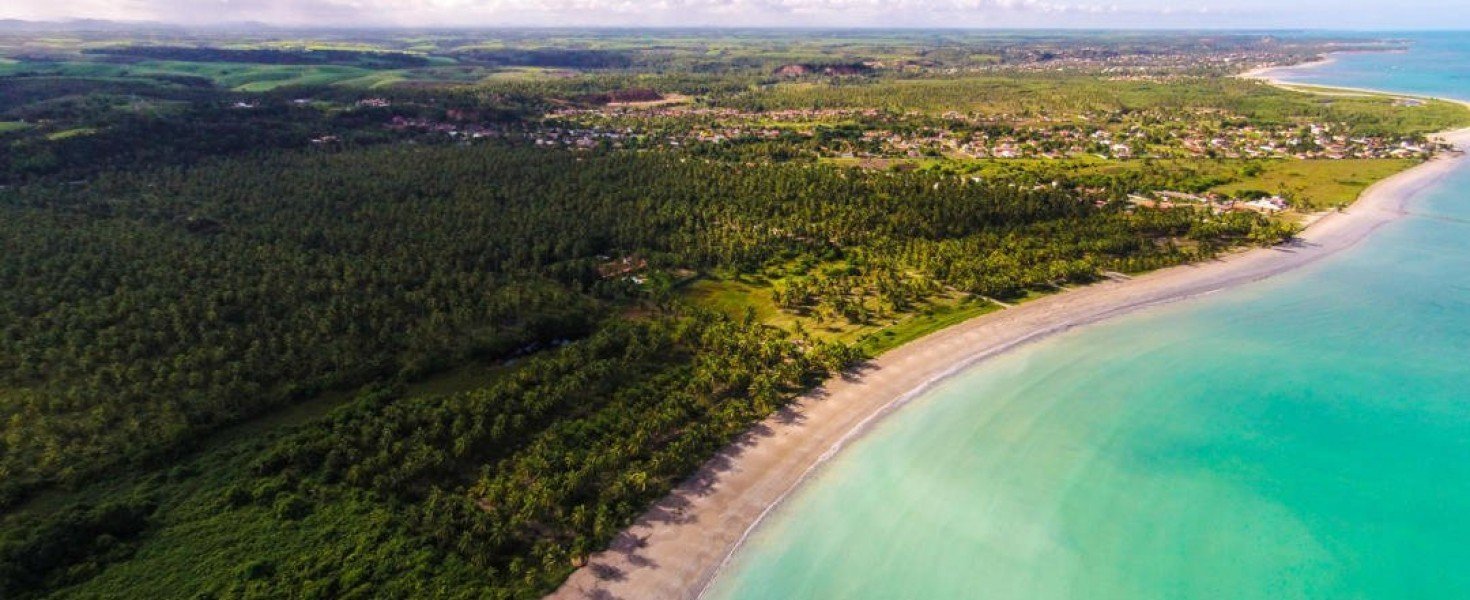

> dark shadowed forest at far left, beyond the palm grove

[{"left": 0, "top": 75, "right": 542, "bottom": 185}]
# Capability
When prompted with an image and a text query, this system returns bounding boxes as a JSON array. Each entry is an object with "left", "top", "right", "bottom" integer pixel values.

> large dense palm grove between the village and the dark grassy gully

[{"left": 0, "top": 142, "right": 1267, "bottom": 502}]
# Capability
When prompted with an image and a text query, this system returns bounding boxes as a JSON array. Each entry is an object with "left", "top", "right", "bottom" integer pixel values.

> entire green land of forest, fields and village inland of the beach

[{"left": 0, "top": 27, "right": 1464, "bottom": 599}]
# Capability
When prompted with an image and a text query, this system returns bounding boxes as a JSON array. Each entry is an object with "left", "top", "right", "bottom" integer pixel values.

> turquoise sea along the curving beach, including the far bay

[{"left": 707, "top": 34, "right": 1470, "bottom": 599}]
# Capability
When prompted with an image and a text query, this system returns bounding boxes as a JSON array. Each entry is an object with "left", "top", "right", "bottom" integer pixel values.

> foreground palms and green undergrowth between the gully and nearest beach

[{"left": 6, "top": 316, "right": 852, "bottom": 597}]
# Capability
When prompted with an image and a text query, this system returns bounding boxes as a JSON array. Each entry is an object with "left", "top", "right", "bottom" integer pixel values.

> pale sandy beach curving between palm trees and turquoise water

[{"left": 548, "top": 76, "right": 1470, "bottom": 599}]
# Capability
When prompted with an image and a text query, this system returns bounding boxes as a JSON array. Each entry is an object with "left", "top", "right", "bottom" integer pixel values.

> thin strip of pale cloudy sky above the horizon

[{"left": 0, "top": 0, "right": 1470, "bottom": 29}]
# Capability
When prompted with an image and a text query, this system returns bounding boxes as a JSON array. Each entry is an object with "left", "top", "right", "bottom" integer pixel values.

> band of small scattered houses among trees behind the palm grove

[{"left": 531, "top": 107, "right": 1436, "bottom": 160}]
